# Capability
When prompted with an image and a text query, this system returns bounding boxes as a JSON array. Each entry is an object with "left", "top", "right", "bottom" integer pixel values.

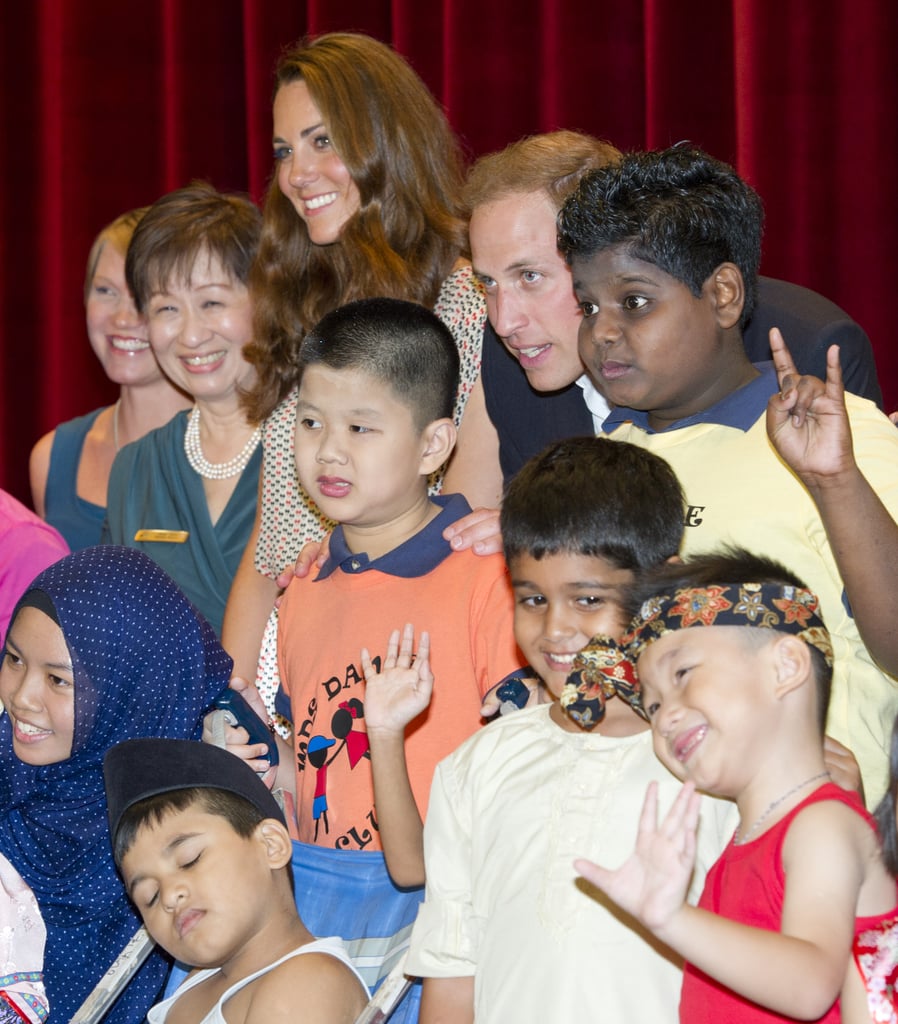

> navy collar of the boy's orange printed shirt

[{"left": 315, "top": 495, "right": 471, "bottom": 582}]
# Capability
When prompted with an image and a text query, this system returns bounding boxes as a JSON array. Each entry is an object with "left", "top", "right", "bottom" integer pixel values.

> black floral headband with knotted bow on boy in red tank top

[{"left": 560, "top": 583, "right": 832, "bottom": 729}]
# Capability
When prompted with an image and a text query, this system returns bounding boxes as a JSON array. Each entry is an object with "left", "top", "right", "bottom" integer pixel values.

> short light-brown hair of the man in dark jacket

[{"left": 463, "top": 131, "right": 621, "bottom": 214}]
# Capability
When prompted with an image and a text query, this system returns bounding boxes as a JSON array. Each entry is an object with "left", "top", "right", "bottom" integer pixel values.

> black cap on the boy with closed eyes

[{"left": 103, "top": 739, "right": 287, "bottom": 839}]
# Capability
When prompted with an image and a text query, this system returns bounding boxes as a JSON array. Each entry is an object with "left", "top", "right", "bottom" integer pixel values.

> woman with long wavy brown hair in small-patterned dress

[{"left": 223, "top": 33, "right": 485, "bottom": 678}]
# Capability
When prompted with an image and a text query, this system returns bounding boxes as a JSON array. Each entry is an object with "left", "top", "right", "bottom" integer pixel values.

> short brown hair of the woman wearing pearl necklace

[{"left": 125, "top": 181, "right": 262, "bottom": 312}]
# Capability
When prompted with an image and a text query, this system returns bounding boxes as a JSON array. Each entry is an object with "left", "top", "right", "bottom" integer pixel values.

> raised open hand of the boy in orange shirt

[{"left": 361, "top": 623, "right": 433, "bottom": 733}]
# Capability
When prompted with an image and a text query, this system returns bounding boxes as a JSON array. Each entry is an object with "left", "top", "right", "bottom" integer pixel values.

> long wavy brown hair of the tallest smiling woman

[{"left": 246, "top": 33, "right": 465, "bottom": 421}]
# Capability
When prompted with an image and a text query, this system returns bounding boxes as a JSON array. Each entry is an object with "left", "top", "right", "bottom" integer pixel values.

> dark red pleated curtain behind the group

[{"left": 0, "top": 0, "right": 898, "bottom": 500}]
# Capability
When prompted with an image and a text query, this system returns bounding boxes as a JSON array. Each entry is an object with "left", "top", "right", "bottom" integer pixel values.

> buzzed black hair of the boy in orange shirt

[{"left": 299, "top": 298, "right": 459, "bottom": 430}]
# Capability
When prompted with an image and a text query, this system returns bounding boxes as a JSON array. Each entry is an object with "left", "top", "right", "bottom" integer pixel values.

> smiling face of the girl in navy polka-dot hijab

[{"left": 0, "top": 606, "right": 75, "bottom": 765}]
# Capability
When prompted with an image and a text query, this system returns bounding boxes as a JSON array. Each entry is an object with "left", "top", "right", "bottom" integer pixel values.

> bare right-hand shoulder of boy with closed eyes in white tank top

[{"left": 244, "top": 952, "right": 368, "bottom": 1024}]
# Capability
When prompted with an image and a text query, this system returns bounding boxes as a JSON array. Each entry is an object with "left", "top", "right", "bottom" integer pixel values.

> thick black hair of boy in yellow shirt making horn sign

[{"left": 558, "top": 145, "right": 764, "bottom": 328}]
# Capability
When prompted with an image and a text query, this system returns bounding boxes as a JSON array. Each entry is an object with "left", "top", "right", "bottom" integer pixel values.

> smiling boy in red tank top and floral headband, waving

[{"left": 575, "top": 550, "right": 898, "bottom": 1024}]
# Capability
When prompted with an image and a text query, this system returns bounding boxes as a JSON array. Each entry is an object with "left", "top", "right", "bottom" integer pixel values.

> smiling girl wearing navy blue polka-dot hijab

[{"left": 0, "top": 546, "right": 231, "bottom": 1024}]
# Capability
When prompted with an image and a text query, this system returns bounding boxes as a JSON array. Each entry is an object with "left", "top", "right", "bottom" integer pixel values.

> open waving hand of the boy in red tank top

[{"left": 573, "top": 782, "right": 700, "bottom": 932}]
